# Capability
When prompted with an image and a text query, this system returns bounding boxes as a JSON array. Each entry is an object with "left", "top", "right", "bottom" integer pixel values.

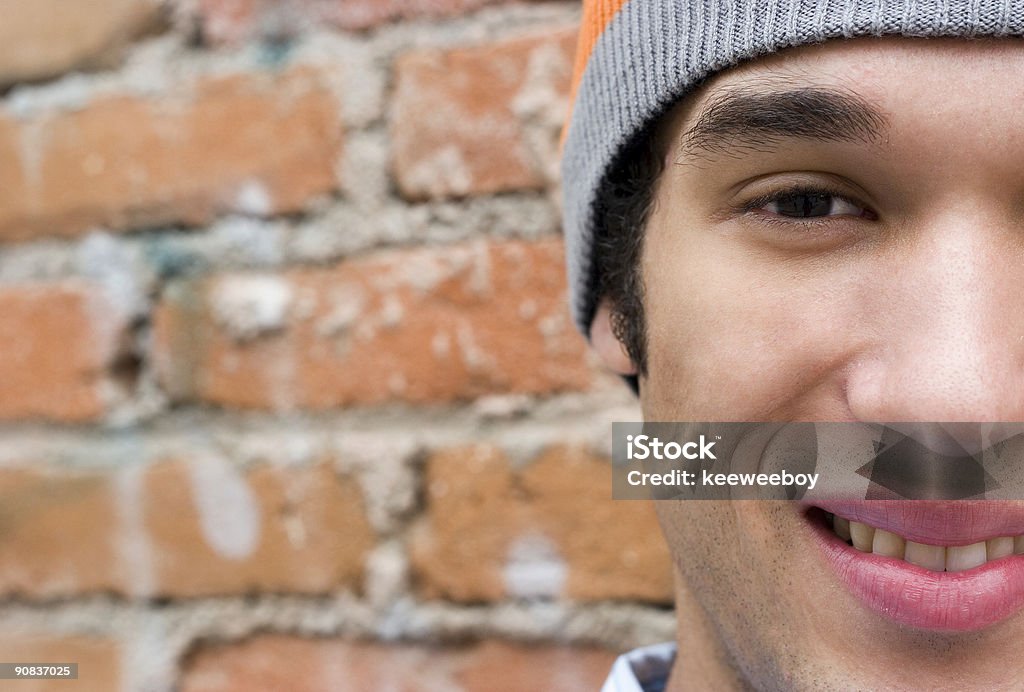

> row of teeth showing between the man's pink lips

[{"left": 825, "top": 514, "right": 1024, "bottom": 572}]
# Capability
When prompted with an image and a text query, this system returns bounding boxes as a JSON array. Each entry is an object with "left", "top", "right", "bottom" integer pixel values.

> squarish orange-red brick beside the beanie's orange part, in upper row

[{"left": 391, "top": 31, "right": 577, "bottom": 200}]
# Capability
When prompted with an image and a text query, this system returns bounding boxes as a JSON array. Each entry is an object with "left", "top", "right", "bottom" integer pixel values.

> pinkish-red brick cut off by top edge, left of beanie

[{"left": 199, "top": 0, "right": 528, "bottom": 44}]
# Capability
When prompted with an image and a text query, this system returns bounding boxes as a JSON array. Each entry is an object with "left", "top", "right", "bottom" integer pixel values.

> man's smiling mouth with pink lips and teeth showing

[{"left": 804, "top": 500, "right": 1024, "bottom": 632}]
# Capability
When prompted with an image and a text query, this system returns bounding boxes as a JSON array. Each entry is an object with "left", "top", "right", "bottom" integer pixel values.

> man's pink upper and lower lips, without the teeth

[{"left": 815, "top": 501, "right": 1024, "bottom": 632}]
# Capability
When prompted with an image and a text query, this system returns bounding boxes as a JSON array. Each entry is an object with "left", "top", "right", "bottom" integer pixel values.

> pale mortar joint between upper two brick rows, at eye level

[{"left": 0, "top": 192, "right": 559, "bottom": 288}]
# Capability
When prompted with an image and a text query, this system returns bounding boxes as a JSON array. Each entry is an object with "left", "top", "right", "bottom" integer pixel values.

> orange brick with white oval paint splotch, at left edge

[{"left": 0, "top": 459, "right": 375, "bottom": 599}]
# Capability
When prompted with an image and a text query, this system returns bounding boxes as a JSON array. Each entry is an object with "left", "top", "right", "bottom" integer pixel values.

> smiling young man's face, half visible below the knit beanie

[{"left": 601, "top": 38, "right": 1024, "bottom": 689}]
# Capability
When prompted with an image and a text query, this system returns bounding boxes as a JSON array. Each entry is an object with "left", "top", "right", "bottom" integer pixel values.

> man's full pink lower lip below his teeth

[{"left": 812, "top": 513, "right": 1024, "bottom": 632}]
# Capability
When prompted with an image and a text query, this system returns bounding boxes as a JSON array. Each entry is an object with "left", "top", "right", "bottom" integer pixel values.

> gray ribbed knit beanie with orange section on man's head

[{"left": 562, "top": 0, "right": 1024, "bottom": 334}]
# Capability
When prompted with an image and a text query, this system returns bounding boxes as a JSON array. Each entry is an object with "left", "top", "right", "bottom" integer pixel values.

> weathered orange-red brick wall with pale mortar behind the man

[{"left": 0, "top": 0, "right": 673, "bottom": 692}]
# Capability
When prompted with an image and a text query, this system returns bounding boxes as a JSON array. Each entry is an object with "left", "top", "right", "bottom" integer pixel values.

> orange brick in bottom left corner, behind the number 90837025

[{"left": 0, "top": 633, "right": 122, "bottom": 692}]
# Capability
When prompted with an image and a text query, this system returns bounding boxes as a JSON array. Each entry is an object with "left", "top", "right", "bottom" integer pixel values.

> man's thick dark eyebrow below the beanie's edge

[{"left": 680, "top": 87, "right": 888, "bottom": 154}]
